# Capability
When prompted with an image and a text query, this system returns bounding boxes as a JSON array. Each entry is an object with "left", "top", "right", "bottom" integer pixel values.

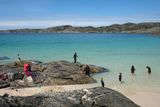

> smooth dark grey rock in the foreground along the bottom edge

[{"left": 0, "top": 87, "right": 139, "bottom": 107}]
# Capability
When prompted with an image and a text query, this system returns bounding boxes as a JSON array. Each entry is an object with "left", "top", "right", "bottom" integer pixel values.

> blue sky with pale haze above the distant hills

[{"left": 0, "top": 0, "right": 160, "bottom": 29}]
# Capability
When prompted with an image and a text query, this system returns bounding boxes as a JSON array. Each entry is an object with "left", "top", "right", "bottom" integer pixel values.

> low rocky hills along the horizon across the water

[{"left": 0, "top": 22, "right": 160, "bottom": 35}]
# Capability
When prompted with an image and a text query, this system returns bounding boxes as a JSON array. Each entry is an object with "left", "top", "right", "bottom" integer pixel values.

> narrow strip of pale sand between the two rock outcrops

[{"left": 0, "top": 84, "right": 95, "bottom": 96}]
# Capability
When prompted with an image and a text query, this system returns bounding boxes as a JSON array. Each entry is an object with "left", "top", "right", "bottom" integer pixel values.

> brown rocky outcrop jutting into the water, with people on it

[{"left": 0, "top": 60, "right": 109, "bottom": 87}]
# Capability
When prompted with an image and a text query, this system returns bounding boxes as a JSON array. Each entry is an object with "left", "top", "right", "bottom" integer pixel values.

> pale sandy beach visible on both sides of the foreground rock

[{"left": 0, "top": 84, "right": 160, "bottom": 107}]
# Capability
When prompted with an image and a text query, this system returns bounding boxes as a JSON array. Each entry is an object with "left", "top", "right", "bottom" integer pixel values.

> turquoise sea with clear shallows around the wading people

[{"left": 0, "top": 33, "right": 160, "bottom": 91}]
